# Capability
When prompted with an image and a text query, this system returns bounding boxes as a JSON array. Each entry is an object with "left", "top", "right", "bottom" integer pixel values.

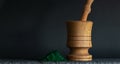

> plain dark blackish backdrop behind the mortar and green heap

[{"left": 0, "top": 0, "right": 120, "bottom": 59}]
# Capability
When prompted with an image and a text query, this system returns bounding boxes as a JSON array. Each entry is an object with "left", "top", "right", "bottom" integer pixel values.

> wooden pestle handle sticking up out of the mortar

[{"left": 81, "top": 0, "right": 94, "bottom": 21}]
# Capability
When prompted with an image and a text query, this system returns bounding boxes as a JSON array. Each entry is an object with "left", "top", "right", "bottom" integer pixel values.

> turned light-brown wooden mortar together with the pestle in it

[{"left": 67, "top": 0, "right": 93, "bottom": 61}]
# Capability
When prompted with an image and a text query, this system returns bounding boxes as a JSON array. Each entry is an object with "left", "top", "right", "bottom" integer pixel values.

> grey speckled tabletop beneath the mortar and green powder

[{"left": 0, "top": 59, "right": 120, "bottom": 64}]
